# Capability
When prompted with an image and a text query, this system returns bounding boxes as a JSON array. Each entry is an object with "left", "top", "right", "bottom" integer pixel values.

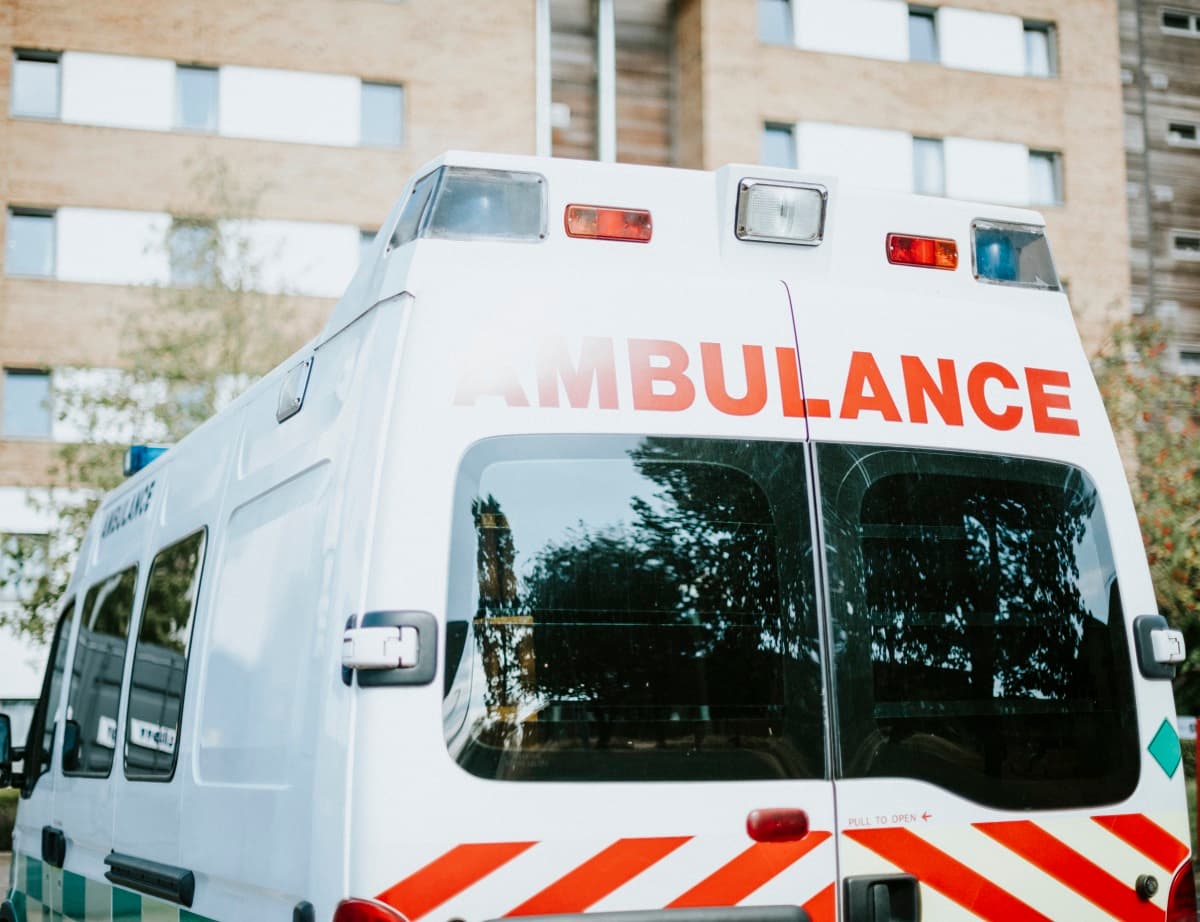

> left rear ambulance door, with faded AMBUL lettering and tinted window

[{"left": 349, "top": 270, "right": 836, "bottom": 922}]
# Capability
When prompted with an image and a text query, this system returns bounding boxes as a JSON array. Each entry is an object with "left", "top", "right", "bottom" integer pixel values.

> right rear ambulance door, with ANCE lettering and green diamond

[{"left": 790, "top": 259, "right": 1188, "bottom": 922}]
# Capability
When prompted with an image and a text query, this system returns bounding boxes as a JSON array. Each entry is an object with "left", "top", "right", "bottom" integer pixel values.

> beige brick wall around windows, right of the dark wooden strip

[{"left": 698, "top": 0, "right": 1129, "bottom": 349}]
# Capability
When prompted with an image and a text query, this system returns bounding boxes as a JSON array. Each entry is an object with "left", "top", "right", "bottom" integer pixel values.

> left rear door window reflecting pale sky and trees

[{"left": 444, "top": 437, "right": 824, "bottom": 780}]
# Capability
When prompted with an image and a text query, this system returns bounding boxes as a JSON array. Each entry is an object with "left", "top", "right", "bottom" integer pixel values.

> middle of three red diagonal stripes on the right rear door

[{"left": 972, "top": 820, "right": 1163, "bottom": 922}]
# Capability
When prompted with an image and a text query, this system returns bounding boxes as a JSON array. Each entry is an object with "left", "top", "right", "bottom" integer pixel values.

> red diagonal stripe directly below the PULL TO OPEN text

[{"left": 844, "top": 828, "right": 1051, "bottom": 922}]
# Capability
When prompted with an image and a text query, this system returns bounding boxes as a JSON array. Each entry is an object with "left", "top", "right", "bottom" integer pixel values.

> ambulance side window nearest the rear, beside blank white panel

[{"left": 125, "top": 531, "right": 205, "bottom": 782}]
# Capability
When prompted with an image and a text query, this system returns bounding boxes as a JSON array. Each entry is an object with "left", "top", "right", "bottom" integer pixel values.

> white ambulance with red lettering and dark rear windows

[{"left": 0, "top": 154, "right": 1195, "bottom": 922}]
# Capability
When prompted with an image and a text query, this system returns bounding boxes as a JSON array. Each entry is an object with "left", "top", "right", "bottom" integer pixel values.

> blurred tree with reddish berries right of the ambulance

[{"left": 1096, "top": 318, "right": 1200, "bottom": 713}]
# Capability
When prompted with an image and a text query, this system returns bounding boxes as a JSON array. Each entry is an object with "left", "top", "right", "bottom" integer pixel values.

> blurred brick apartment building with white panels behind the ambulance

[{"left": 0, "top": 0, "right": 1176, "bottom": 696}]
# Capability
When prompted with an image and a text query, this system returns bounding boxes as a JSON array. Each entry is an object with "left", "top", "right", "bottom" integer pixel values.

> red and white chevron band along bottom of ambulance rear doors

[{"left": 377, "top": 814, "right": 1189, "bottom": 922}]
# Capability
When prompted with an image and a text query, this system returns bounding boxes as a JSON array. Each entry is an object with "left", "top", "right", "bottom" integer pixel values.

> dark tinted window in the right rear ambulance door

[{"left": 818, "top": 445, "right": 1139, "bottom": 809}]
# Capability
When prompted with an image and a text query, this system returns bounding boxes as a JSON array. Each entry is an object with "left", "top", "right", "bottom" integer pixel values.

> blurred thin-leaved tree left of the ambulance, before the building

[{"left": 0, "top": 160, "right": 300, "bottom": 640}]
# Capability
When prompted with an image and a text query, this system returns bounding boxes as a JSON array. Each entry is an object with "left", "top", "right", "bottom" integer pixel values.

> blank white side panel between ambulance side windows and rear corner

[{"left": 180, "top": 303, "right": 400, "bottom": 918}]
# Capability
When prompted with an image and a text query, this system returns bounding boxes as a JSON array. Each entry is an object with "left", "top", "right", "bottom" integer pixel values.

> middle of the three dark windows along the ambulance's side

[{"left": 62, "top": 567, "right": 138, "bottom": 778}]
